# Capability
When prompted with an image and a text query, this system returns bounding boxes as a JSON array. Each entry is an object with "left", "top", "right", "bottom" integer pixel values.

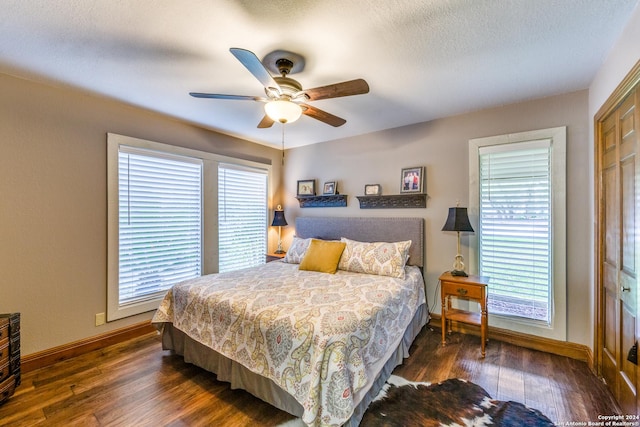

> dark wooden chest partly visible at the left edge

[{"left": 0, "top": 313, "right": 20, "bottom": 404}]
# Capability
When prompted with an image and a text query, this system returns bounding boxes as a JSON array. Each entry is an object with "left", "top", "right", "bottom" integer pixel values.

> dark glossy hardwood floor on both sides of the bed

[{"left": 0, "top": 326, "right": 620, "bottom": 427}]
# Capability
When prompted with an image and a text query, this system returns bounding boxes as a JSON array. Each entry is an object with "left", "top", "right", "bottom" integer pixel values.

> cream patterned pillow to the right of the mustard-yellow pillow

[{"left": 338, "top": 237, "right": 411, "bottom": 279}]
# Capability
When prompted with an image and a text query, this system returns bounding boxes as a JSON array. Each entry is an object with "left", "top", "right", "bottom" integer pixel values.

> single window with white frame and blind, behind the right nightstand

[{"left": 469, "top": 128, "right": 566, "bottom": 339}]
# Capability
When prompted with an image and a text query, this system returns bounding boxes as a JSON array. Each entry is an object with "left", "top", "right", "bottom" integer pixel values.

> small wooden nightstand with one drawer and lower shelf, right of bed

[{"left": 440, "top": 271, "right": 489, "bottom": 357}]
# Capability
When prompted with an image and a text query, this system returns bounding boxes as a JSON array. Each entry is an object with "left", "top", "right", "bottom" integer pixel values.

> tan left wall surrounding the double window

[{"left": 0, "top": 74, "right": 281, "bottom": 355}]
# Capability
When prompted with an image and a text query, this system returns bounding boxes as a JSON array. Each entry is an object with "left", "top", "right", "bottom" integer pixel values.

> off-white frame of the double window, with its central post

[{"left": 107, "top": 133, "right": 272, "bottom": 322}]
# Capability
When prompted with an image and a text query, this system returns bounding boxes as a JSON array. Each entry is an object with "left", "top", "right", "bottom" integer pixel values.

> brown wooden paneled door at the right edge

[{"left": 596, "top": 83, "right": 640, "bottom": 414}]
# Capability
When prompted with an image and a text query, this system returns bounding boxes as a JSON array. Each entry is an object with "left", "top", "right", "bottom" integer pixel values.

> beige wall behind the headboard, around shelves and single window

[{"left": 282, "top": 91, "right": 592, "bottom": 346}]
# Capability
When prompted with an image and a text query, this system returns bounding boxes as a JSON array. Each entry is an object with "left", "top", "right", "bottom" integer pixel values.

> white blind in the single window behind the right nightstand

[{"left": 478, "top": 140, "right": 553, "bottom": 324}]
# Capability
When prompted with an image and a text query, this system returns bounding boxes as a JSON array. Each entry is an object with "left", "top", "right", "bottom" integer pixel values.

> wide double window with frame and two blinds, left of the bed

[{"left": 107, "top": 134, "right": 270, "bottom": 321}]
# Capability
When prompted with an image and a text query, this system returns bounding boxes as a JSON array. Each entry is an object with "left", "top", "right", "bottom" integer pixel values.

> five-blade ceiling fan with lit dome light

[{"left": 189, "top": 48, "right": 369, "bottom": 128}]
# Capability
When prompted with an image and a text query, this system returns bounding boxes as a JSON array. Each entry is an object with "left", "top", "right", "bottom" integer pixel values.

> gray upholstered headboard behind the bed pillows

[{"left": 296, "top": 217, "right": 424, "bottom": 267}]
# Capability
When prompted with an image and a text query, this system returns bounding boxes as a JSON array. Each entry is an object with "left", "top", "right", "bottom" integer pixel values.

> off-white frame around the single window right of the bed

[{"left": 468, "top": 126, "right": 567, "bottom": 341}]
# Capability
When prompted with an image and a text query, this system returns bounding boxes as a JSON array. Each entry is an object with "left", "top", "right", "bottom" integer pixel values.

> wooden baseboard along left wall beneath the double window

[{"left": 20, "top": 321, "right": 155, "bottom": 373}]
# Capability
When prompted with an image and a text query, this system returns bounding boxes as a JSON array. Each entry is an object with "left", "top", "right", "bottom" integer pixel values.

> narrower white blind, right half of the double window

[{"left": 218, "top": 164, "right": 267, "bottom": 273}]
